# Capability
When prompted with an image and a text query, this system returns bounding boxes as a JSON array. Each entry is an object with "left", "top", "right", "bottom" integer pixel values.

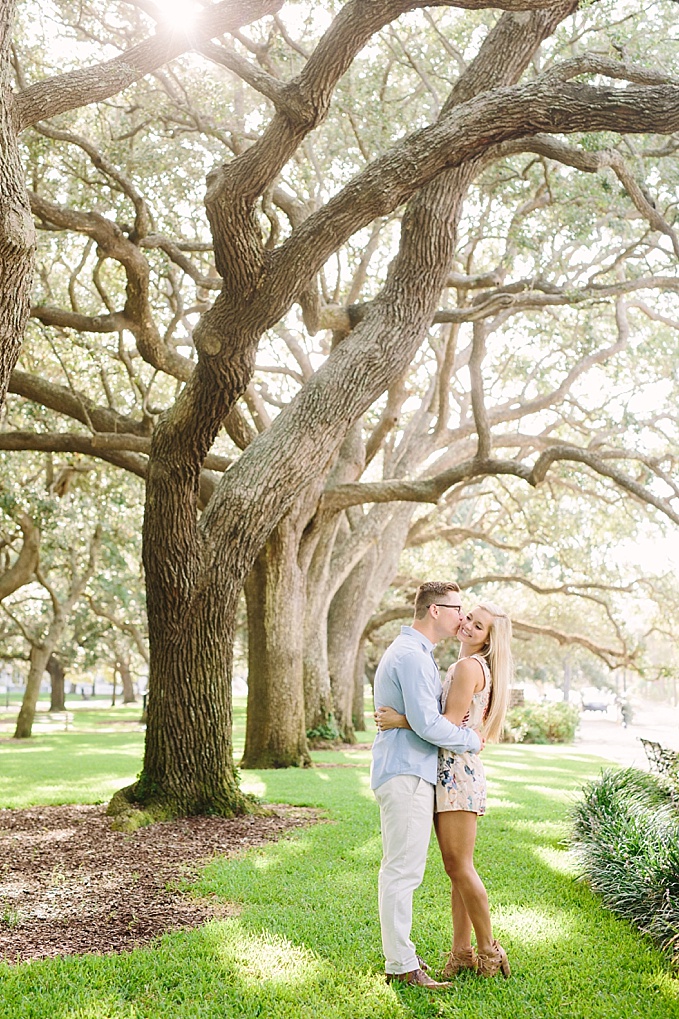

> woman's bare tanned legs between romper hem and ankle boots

[{"left": 435, "top": 810, "right": 492, "bottom": 952}]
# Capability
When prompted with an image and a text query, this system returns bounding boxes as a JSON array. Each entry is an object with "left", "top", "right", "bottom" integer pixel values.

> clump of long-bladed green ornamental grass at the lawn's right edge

[{"left": 573, "top": 768, "right": 679, "bottom": 964}]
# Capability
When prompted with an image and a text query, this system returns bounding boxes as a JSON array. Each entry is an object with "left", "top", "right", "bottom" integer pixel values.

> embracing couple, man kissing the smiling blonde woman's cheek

[{"left": 371, "top": 582, "right": 512, "bottom": 989}]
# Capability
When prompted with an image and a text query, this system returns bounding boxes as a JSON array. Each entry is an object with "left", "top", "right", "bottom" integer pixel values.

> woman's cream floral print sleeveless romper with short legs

[{"left": 435, "top": 654, "right": 492, "bottom": 816}]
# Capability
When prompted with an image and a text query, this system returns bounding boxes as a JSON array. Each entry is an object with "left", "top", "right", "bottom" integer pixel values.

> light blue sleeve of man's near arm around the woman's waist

[{"left": 399, "top": 653, "right": 481, "bottom": 754}]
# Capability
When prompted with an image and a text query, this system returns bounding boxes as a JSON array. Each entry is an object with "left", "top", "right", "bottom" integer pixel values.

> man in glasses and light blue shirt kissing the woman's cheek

[{"left": 370, "top": 581, "right": 483, "bottom": 989}]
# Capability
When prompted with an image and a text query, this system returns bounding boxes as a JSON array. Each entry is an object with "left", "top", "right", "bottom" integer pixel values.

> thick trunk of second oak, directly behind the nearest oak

[{"left": 241, "top": 517, "right": 311, "bottom": 767}]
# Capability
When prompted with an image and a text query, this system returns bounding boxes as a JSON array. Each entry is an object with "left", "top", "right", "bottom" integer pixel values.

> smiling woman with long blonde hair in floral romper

[{"left": 375, "top": 602, "right": 512, "bottom": 977}]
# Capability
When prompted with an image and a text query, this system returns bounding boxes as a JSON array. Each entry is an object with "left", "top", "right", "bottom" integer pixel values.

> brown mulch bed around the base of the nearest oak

[{"left": 0, "top": 805, "right": 317, "bottom": 962}]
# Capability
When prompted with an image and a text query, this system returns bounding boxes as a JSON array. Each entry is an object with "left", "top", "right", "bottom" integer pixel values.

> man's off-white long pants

[{"left": 374, "top": 774, "right": 434, "bottom": 973}]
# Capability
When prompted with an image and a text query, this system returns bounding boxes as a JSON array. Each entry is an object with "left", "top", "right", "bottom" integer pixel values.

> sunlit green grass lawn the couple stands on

[{"left": 0, "top": 705, "right": 679, "bottom": 1019}]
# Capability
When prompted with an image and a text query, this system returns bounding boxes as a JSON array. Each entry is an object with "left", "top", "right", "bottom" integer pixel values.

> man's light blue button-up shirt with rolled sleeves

[{"left": 370, "top": 627, "right": 481, "bottom": 789}]
